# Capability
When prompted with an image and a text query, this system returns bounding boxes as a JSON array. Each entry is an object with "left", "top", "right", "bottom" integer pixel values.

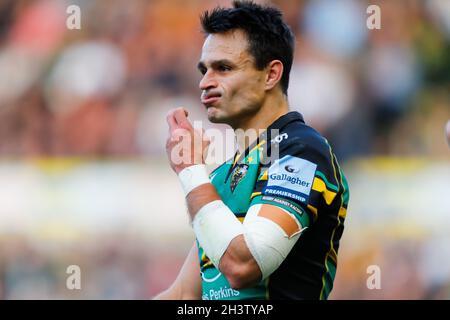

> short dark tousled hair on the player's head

[{"left": 200, "top": 1, "right": 295, "bottom": 95}]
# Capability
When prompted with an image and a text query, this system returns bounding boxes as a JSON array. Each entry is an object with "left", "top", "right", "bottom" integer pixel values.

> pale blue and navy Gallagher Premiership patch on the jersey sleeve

[{"left": 262, "top": 155, "right": 317, "bottom": 203}]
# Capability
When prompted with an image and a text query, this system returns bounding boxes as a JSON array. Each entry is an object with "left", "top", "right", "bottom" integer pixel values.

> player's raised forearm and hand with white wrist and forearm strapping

[{"left": 162, "top": 109, "right": 259, "bottom": 297}]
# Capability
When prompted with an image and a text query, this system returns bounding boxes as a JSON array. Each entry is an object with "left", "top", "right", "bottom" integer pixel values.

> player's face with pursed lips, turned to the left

[{"left": 198, "top": 30, "right": 266, "bottom": 127}]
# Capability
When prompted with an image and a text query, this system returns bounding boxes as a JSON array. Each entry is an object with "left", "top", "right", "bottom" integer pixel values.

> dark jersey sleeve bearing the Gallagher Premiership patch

[{"left": 250, "top": 137, "right": 336, "bottom": 228}]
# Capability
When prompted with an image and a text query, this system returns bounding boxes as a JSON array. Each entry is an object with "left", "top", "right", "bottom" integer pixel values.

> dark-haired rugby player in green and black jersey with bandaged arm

[{"left": 156, "top": 1, "right": 349, "bottom": 300}]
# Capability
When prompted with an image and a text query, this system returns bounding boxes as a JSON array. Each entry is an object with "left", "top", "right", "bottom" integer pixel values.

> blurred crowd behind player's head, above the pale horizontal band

[{"left": 0, "top": 0, "right": 450, "bottom": 159}]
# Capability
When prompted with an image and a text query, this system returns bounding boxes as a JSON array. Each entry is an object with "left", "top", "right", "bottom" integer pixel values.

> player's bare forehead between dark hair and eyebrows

[{"left": 200, "top": 30, "right": 251, "bottom": 64}]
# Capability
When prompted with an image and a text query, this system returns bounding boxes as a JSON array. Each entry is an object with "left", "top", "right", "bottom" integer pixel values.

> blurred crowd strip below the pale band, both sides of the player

[{"left": 0, "top": 229, "right": 450, "bottom": 300}]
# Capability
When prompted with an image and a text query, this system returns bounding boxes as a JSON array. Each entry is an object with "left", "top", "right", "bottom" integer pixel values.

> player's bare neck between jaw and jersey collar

[{"left": 233, "top": 93, "right": 289, "bottom": 153}]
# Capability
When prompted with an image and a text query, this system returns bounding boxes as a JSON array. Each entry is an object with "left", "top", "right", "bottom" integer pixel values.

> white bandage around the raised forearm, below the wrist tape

[{"left": 192, "top": 200, "right": 244, "bottom": 269}]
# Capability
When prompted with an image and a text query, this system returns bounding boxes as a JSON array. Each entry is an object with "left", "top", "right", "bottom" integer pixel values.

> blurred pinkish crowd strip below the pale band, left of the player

[{"left": 0, "top": 233, "right": 186, "bottom": 300}]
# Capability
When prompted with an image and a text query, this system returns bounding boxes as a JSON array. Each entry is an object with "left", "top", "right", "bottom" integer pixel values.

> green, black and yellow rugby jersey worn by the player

[{"left": 197, "top": 112, "right": 349, "bottom": 300}]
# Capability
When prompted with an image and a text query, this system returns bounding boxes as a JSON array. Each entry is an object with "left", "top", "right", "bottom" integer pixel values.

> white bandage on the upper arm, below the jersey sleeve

[{"left": 243, "top": 204, "right": 301, "bottom": 280}]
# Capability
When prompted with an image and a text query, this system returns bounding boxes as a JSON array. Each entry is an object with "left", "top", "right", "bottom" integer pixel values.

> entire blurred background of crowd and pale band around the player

[{"left": 0, "top": 0, "right": 450, "bottom": 299}]
